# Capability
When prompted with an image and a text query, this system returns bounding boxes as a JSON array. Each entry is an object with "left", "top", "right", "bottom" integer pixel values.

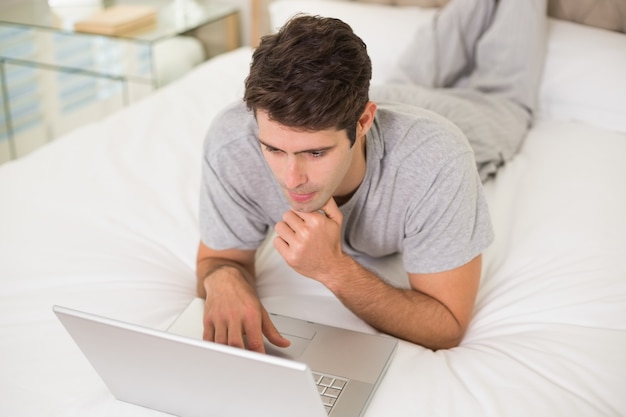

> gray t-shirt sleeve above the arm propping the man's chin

[{"left": 402, "top": 152, "right": 494, "bottom": 273}]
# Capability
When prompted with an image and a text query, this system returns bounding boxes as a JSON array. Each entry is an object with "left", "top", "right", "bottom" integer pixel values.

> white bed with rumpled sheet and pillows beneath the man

[{"left": 0, "top": 0, "right": 626, "bottom": 417}]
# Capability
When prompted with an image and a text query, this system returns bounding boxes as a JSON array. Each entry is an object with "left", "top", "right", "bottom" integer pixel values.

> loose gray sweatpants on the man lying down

[{"left": 371, "top": 0, "right": 547, "bottom": 181}]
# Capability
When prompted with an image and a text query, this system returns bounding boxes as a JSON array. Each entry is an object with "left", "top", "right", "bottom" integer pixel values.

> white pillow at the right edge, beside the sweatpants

[{"left": 539, "top": 19, "right": 626, "bottom": 132}]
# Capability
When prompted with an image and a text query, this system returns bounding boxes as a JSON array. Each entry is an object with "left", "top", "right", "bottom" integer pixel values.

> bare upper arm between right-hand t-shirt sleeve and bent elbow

[{"left": 409, "top": 255, "right": 482, "bottom": 332}]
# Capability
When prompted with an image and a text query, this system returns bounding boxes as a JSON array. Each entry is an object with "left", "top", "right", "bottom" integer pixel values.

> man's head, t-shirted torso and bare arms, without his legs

[{"left": 197, "top": 0, "right": 544, "bottom": 352}]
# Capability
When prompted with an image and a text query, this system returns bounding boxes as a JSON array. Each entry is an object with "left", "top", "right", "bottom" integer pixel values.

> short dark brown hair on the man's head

[{"left": 244, "top": 15, "right": 372, "bottom": 143}]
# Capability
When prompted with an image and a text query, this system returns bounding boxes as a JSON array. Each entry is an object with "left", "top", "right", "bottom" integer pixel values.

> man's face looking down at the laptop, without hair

[{"left": 257, "top": 110, "right": 365, "bottom": 212}]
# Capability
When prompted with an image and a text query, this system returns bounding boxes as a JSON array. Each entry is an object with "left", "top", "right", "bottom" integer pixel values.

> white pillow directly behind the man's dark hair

[{"left": 269, "top": 0, "right": 436, "bottom": 84}]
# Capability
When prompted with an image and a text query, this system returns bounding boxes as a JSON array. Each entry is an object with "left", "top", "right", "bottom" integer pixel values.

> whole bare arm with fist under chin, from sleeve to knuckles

[{"left": 274, "top": 198, "right": 481, "bottom": 349}]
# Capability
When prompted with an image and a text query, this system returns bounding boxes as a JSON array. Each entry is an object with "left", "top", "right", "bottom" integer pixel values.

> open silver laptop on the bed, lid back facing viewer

[{"left": 53, "top": 298, "right": 398, "bottom": 417}]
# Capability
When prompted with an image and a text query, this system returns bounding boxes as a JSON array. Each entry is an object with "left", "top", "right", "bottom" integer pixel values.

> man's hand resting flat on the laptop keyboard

[{"left": 202, "top": 264, "right": 290, "bottom": 353}]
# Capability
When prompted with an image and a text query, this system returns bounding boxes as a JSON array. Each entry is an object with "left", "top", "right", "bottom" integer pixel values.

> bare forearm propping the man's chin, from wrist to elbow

[{"left": 322, "top": 257, "right": 464, "bottom": 350}]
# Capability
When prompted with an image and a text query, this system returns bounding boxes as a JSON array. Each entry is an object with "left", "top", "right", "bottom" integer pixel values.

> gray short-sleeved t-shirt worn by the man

[{"left": 200, "top": 103, "right": 493, "bottom": 273}]
